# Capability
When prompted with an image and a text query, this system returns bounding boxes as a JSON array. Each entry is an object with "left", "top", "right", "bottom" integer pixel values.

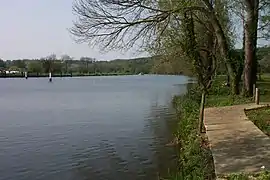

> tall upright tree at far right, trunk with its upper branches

[{"left": 231, "top": 0, "right": 270, "bottom": 96}]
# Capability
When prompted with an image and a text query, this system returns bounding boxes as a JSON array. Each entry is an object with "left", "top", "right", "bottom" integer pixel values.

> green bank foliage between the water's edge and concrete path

[{"left": 166, "top": 84, "right": 214, "bottom": 180}]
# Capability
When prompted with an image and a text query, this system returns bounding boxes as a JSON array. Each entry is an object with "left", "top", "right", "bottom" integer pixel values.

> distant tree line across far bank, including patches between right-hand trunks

[{"left": 0, "top": 47, "right": 270, "bottom": 76}]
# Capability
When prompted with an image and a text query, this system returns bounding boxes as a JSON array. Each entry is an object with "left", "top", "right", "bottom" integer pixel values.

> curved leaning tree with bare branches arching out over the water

[{"left": 70, "top": 0, "right": 238, "bottom": 93}]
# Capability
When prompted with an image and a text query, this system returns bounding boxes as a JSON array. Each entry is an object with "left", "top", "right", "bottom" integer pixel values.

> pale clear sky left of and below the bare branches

[{"left": 0, "top": 0, "right": 146, "bottom": 60}]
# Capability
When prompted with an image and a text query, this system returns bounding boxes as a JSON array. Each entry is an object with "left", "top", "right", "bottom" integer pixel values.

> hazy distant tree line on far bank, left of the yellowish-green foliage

[{"left": 0, "top": 55, "right": 181, "bottom": 76}]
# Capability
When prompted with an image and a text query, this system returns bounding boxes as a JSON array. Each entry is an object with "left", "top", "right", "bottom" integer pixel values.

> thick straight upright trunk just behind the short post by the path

[{"left": 243, "top": 0, "right": 259, "bottom": 97}]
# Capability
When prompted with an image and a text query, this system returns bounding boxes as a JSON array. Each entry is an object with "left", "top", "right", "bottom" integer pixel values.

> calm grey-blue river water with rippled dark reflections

[{"left": 0, "top": 75, "right": 188, "bottom": 180}]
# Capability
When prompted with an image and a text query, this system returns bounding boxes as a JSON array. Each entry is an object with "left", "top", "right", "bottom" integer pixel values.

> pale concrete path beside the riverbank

[{"left": 204, "top": 104, "right": 270, "bottom": 176}]
